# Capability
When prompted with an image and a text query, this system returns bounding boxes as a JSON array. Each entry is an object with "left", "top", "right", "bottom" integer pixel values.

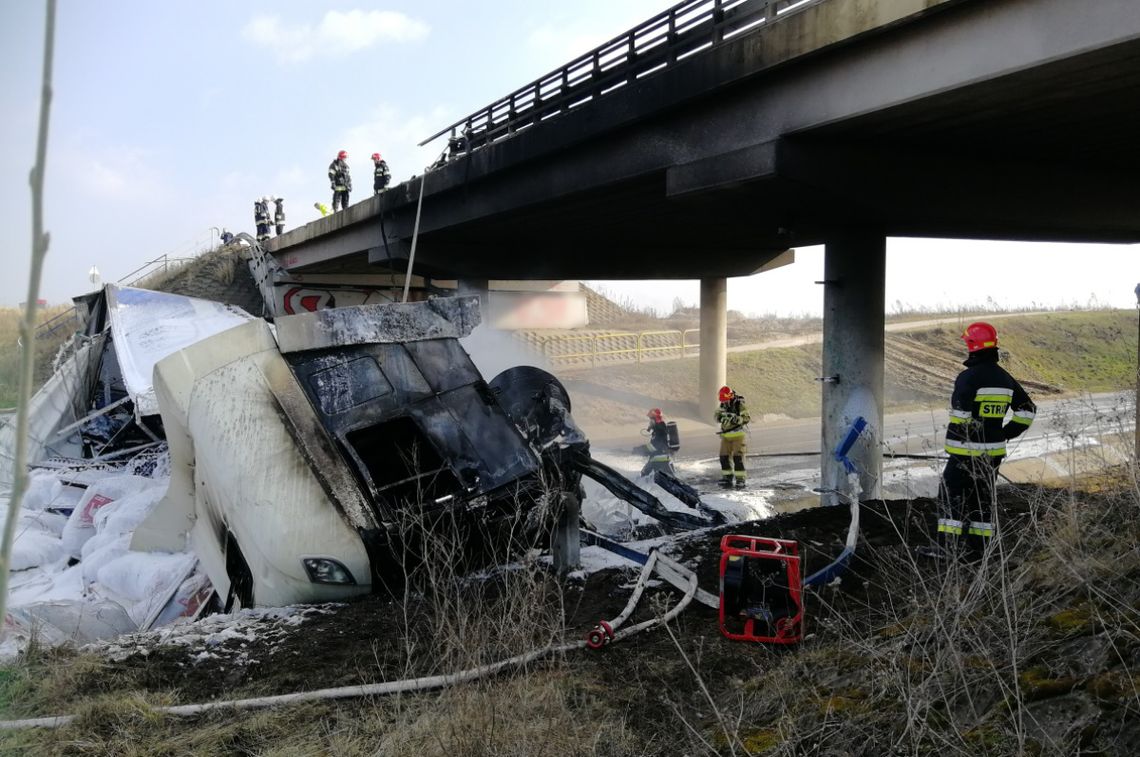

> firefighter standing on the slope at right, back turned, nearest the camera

[{"left": 938, "top": 323, "right": 1037, "bottom": 556}]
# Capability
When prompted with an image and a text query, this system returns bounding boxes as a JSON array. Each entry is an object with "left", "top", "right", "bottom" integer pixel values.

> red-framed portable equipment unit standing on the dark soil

[{"left": 719, "top": 535, "right": 804, "bottom": 644}]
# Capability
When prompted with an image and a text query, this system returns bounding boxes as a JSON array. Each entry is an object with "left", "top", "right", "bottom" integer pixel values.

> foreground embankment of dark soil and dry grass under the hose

[{"left": 0, "top": 478, "right": 1140, "bottom": 755}]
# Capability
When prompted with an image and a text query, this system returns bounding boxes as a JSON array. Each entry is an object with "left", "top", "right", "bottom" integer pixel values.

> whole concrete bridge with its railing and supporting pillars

[{"left": 269, "top": 0, "right": 1140, "bottom": 506}]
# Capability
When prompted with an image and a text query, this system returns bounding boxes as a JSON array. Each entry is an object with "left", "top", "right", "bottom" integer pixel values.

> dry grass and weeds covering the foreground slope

[{"left": 0, "top": 469, "right": 1140, "bottom": 756}]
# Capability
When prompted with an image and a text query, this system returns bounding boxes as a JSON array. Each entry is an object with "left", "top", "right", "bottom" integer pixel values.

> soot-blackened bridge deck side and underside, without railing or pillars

[{"left": 270, "top": 0, "right": 1140, "bottom": 278}]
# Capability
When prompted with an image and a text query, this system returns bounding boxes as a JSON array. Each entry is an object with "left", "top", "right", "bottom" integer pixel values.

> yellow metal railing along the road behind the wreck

[{"left": 515, "top": 328, "right": 700, "bottom": 368}]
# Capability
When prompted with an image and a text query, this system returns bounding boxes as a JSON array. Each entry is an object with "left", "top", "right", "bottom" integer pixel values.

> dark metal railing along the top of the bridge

[{"left": 420, "top": 0, "right": 825, "bottom": 150}]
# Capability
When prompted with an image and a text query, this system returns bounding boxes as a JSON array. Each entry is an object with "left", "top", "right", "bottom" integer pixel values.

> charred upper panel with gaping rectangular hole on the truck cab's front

[{"left": 286, "top": 339, "right": 537, "bottom": 521}]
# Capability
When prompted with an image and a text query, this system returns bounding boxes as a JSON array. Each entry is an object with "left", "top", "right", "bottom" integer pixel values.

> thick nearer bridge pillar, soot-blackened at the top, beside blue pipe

[{"left": 820, "top": 231, "right": 887, "bottom": 505}]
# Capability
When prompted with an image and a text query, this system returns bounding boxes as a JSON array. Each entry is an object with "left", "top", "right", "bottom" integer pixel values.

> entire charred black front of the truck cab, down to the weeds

[{"left": 286, "top": 330, "right": 548, "bottom": 588}]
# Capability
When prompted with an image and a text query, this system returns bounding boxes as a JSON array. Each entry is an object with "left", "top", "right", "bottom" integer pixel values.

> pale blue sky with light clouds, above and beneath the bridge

[{"left": 0, "top": 0, "right": 1140, "bottom": 315}]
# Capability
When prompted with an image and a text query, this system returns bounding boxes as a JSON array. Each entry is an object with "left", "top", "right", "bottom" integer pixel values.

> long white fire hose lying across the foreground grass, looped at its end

[{"left": 0, "top": 552, "right": 697, "bottom": 731}]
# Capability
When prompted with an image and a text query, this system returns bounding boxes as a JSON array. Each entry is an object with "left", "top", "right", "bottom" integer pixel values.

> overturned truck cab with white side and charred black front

[{"left": 131, "top": 298, "right": 579, "bottom": 609}]
